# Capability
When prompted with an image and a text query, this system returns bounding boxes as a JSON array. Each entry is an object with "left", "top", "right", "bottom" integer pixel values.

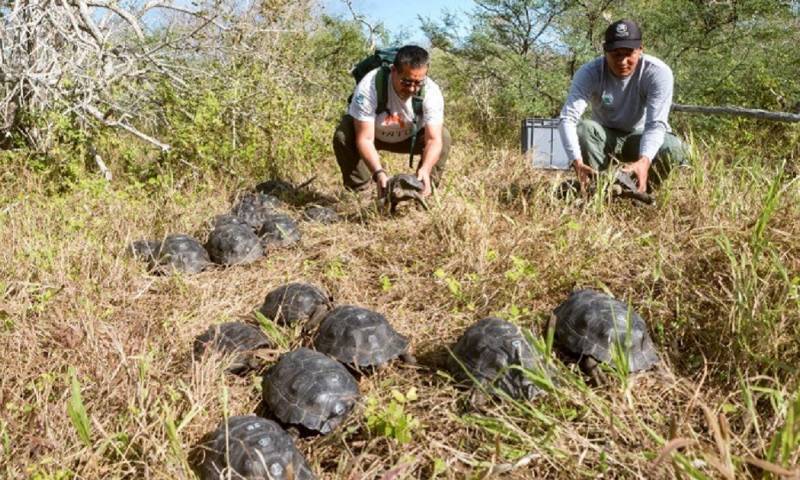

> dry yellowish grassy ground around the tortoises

[{"left": 0, "top": 141, "right": 800, "bottom": 479}]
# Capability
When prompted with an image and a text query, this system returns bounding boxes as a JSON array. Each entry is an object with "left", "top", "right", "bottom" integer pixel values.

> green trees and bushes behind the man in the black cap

[{"left": 423, "top": 0, "right": 800, "bottom": 156}]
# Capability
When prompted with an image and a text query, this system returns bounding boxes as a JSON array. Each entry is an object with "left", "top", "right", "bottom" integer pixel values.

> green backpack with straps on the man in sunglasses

[{"left": 347, "top": 47, "right": 425, "bottom": 168}]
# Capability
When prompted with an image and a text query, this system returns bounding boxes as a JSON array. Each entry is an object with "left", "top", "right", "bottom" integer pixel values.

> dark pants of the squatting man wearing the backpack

[{"left": 333, "top": 115, "right": 452, "bottom": 190}]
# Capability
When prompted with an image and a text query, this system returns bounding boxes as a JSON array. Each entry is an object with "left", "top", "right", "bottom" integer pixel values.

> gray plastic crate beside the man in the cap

[{"left": 521, "top": 118, "right": 570, "bottom": 170}]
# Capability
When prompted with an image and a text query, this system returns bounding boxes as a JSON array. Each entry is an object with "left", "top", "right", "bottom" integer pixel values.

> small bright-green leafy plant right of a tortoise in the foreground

[{"left": 365, "top": 387, "right": 421, "bottom": 445}]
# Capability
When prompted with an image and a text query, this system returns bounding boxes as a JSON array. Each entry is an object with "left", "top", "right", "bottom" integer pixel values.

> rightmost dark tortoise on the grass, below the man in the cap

[{"left": 553, "top": 290, "right": 659, "bottom": 383}]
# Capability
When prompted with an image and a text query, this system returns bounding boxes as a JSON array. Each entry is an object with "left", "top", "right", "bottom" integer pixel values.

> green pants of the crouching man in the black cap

[{"left": 578, "top": 120, "right": 689, "bottom": 185}]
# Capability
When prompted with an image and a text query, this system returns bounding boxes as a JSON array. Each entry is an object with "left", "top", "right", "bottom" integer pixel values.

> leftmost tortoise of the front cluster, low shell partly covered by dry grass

[{"left": 194, "top": 322, "right": 274, "bottom": 374}]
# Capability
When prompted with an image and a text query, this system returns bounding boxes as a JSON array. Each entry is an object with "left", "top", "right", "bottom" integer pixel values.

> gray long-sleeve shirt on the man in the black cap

[{"left": 559, "top": 55, "right": 673, "bottom": 161}]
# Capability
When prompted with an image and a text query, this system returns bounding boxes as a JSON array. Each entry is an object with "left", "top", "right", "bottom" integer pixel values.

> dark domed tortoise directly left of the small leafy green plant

[{"left": 262, "top": 348, "right": 359, "bottom": 435}]
